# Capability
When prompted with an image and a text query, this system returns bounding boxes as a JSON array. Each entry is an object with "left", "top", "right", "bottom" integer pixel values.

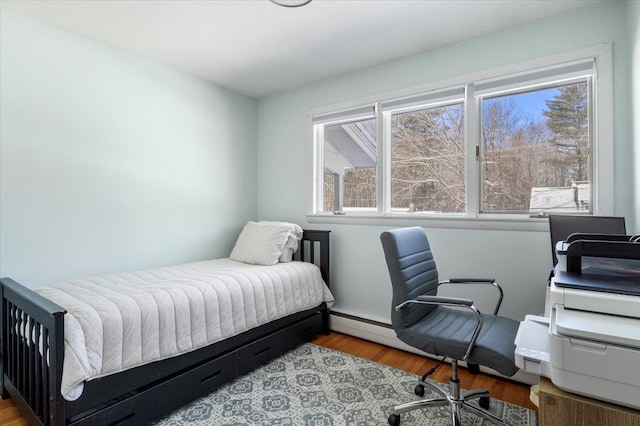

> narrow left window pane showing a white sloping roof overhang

[{"left": 323, "top": 119, "right": 377, "bottom": 211}]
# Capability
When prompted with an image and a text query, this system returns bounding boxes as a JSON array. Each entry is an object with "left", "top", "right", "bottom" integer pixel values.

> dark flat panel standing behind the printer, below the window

[{"left": 549, "top": 215, "right": 627, "bottom": 266}]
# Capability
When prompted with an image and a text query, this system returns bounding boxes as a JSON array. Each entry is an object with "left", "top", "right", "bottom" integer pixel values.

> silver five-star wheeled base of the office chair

[{"left": 389, "top": 360, "right": 509, "bottom": 426}]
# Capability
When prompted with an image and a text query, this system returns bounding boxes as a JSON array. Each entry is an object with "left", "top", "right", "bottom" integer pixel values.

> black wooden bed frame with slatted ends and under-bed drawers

[{"left": 0, "top": 230, "right": 330, "bottom": 425}]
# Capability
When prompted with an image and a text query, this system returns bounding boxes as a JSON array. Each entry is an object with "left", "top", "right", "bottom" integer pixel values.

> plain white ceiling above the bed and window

[{"left": 0, "top": 0, "right": 597, "bottom": 97}]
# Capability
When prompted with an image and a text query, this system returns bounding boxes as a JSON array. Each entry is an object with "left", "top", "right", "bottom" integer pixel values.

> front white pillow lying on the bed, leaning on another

[{"left": 229, "top": 221, "right": 291, "bottom": 265}]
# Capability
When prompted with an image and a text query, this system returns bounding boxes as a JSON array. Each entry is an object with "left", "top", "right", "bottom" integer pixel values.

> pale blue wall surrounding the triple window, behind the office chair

[{"left": 258, "top": 1, "right": 640, "bottom": 321}]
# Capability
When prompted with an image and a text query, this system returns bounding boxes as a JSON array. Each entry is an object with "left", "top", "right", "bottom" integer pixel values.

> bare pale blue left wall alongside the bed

[{"left": 0, "top": 11, "right": 258, "bottom": 287}]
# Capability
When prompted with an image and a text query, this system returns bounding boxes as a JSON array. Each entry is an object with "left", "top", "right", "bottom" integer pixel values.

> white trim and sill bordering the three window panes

[{"left": 307, "top": 42, "right": 614, "bottom": 231}]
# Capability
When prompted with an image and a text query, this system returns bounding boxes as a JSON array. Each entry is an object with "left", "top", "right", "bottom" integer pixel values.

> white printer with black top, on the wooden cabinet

[{"left": 515, "top": 234, "right": 640, "bottom": 409}]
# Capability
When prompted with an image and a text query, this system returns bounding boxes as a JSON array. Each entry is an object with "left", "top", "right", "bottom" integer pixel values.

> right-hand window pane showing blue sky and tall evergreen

[{"left": 481, "top": 81, "right": 591, "bottom": 213}]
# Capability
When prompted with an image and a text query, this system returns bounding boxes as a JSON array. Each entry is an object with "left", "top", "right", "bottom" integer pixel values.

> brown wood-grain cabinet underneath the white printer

[{"left": 538, "top": 377, "right": 640, "bottom": 426}]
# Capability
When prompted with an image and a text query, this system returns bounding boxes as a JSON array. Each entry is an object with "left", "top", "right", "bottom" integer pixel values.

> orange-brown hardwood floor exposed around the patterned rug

[{"left": 0, "top": 333, "right": 537, "bottom": 426}]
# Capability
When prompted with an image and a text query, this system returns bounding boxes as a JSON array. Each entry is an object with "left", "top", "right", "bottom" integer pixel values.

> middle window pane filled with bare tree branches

[{"left": 391, "top": 104, "right": 466, "bottom": 213}]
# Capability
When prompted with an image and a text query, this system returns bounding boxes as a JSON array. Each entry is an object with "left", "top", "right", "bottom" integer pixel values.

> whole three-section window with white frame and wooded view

[{"left": 311, "top": 44, "right": 613, "bottom": 225}]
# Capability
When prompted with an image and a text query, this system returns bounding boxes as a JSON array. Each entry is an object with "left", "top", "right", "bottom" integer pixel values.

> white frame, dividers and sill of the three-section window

[{"left": 307, "top": 43, "right": 614, "bottom": 231}]
